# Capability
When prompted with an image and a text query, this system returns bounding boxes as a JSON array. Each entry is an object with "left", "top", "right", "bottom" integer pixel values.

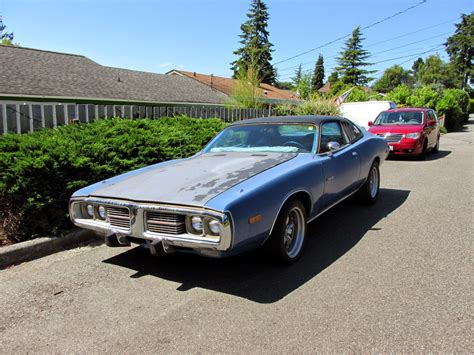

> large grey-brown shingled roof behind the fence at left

[{"left": 0, "top": 45, "right": 227, "bottom": 104}]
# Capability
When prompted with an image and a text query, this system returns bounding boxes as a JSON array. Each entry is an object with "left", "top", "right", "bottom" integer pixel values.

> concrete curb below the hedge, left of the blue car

[{"left": 0, "top": 229, "right": 100, "bottom": 269}]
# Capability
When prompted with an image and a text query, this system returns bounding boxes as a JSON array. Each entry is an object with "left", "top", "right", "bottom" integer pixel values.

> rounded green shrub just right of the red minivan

[{"left": 436, "top": 89, "right": 469, "bottom": 131}]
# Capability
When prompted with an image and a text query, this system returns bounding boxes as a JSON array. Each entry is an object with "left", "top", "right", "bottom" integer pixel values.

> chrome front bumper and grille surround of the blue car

[{"left": 69, "top": 197, "right": 233, "bottom": 252}]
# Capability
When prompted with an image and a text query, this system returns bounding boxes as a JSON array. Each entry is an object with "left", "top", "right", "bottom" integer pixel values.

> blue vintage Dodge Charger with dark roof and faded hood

[{"left": 69, "top": 116, "right": 388, "bottom": 263}]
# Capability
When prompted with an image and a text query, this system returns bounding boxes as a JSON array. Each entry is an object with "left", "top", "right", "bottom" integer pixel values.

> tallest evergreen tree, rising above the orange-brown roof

[{"left": 231, "top": 0, "right": 276, "bottom": 84}]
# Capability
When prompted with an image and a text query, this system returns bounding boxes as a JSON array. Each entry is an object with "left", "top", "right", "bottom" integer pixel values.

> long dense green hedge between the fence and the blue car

[{"left": 0, "top": 117, "right": 226, "bottom": 242}]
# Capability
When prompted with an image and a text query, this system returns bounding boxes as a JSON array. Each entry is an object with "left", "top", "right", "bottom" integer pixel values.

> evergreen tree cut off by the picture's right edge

[{"left": 445, "top": 13, "right": 474, "bottom": 89}]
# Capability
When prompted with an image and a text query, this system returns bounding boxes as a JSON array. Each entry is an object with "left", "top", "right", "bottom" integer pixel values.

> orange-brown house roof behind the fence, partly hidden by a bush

[{"left": 166, "top": 69, "right": 298, "bottom": 104}]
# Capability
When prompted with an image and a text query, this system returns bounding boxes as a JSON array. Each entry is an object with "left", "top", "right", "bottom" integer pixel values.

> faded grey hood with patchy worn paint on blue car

[{"left": 79, "top": 153, "right": 297, "bottom": 206}]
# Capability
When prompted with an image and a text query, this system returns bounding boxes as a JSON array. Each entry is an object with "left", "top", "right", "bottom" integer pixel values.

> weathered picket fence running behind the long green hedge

[{"left": 0, "top": 101, "right": 271, "bottom": 134}]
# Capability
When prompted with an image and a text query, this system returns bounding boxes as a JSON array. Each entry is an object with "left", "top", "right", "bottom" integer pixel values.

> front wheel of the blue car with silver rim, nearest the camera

[{"left": 266, "top": 200, "right": 307, "bottom": 264}]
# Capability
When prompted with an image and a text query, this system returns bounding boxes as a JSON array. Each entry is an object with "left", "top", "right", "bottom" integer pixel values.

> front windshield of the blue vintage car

[{"left": 205, "top": 124, "right": 316, "bottom": 153}]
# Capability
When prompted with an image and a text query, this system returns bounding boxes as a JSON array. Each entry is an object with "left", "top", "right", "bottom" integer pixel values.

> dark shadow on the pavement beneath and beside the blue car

[{"left": 103, "top": 189, "right": 410, "bottom": 303}]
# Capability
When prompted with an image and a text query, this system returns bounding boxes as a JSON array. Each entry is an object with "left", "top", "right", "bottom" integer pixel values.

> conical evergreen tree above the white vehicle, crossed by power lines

[{"left": 336, "top": 27, "right": 374, "bottom": 86}]
